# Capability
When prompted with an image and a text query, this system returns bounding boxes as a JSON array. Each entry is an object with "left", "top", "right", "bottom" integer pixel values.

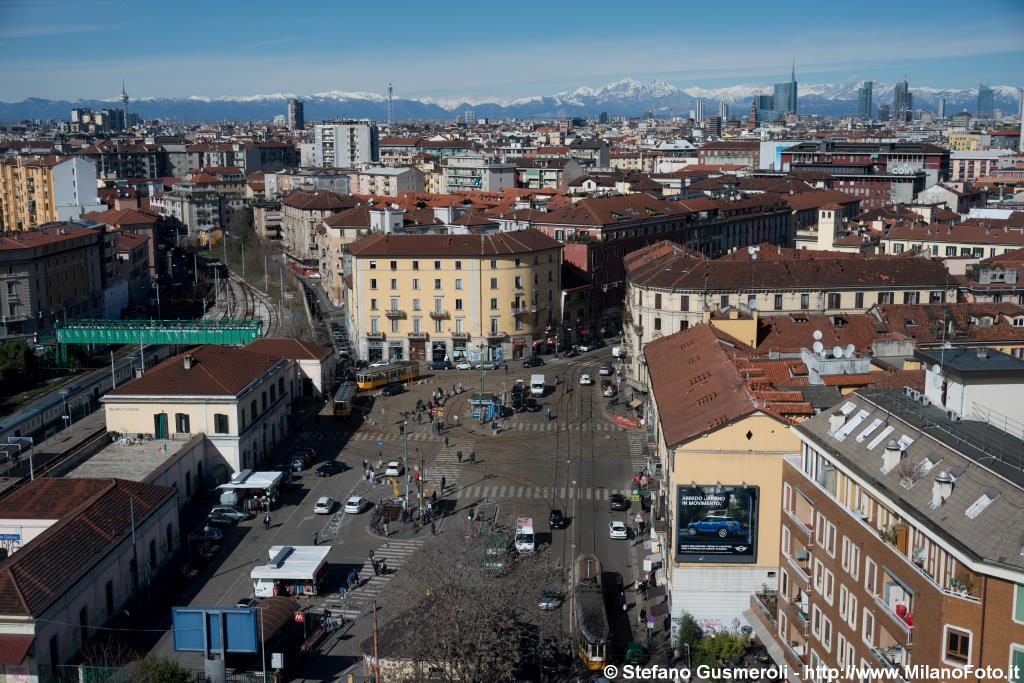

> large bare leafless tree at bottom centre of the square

[{"left": 381, "top": 519, "right": 568, "bottom": 683}]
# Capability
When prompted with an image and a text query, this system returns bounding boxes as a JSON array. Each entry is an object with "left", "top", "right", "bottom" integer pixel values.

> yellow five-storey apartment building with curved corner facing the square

[{"left": 345, "top": 229, "right": 562, "bottom": 361}]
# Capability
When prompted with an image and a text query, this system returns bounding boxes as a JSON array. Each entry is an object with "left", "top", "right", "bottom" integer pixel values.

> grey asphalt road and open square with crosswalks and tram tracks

[{"left": 154, "top": 348, "right": 649, "bottom": 681}]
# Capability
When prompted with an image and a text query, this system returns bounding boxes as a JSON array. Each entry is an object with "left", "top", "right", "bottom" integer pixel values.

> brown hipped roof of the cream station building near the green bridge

[{"left": 106, "top": 344, "right": 280, "bottom": 396}]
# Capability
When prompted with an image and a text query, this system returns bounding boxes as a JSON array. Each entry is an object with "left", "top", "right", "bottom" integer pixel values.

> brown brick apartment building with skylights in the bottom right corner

[{"left": 751, "top": 382, "right": 1024, "bottom": 681}]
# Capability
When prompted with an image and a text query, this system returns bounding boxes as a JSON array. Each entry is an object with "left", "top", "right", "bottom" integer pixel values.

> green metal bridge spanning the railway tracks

[{"left": 53, "top": 319, "right": 263, "bottom": 360}]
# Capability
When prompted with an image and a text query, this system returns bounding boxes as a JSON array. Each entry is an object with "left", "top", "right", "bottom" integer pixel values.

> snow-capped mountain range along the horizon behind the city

[{"left": 0, "top": 78, "right": 1019, "bottom": 121}]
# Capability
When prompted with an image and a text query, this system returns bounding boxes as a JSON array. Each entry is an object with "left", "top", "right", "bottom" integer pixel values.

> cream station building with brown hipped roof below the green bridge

[{"left": 100, "top": 344, "right": 300, "bottom": 472}]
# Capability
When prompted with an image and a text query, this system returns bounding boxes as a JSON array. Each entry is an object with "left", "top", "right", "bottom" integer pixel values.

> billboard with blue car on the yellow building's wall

[{"left": 676, "top": 484, "right": 758, "bottom": 563}]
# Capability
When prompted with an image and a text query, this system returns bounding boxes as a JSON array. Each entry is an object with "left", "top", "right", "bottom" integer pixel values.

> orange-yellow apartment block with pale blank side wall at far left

[{"left": 0, "top": 156, "right": 103, "bottom": 231}]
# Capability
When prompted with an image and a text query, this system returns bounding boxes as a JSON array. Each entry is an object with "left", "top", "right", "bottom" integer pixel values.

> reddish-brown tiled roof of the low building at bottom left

[{"left": 0, "top": 477, "right": 176, "bottom": 616}]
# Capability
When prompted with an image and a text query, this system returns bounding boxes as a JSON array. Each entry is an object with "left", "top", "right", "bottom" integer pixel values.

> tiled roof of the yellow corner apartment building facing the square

[{"left": 348, "top": 228, "right": 561, "bottom": 257}]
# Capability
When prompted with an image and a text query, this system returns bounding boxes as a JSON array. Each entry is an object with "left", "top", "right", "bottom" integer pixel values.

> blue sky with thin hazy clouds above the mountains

[{"left": 0, "top": 0, "right": 1024, "bottom": 101}]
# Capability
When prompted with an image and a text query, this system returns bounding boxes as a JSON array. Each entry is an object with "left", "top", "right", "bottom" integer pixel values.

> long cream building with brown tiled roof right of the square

[{"left": 623, "top": 243, "right": 956, "bottom": 392}]
